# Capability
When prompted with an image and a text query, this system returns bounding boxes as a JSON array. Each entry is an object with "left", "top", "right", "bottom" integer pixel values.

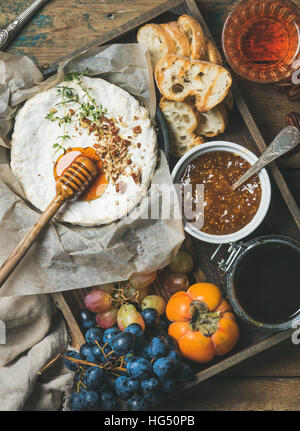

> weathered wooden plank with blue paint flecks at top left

[{"left": 0, "top": 0, "right": 175, "bottom": 65}]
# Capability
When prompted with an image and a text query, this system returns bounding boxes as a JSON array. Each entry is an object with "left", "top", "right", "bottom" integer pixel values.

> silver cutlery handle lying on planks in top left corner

[{"left": 0, "top": 0, "right": 49, "bottom": 51}]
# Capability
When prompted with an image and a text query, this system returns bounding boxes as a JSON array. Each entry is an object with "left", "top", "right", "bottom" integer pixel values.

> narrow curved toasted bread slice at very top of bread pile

[{"left": 177, "top": 15, "right": 205, "bottom": 60}]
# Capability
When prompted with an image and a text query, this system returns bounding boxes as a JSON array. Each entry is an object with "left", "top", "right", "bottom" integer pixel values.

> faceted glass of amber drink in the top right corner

[{"left": 222, "top": 0, "right": 300, "bottom": 83}]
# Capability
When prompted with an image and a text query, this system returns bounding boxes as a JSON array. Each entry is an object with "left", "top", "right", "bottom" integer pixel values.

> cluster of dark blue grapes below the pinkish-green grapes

[{"left": 64, "top": 308, "right": 194, "bottom": 411}]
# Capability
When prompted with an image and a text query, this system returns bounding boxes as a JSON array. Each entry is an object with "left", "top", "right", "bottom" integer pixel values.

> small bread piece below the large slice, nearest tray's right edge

[{"left": 195, "top": 102, "right": 228, "bottom": 138}]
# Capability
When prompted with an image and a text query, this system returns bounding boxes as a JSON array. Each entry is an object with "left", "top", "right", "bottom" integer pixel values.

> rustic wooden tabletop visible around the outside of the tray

[{"left": 0, "top": 0, "right": 300, "bottom": 410}]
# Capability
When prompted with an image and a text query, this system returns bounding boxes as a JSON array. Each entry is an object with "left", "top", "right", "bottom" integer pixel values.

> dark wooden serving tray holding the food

[{"left": 53, "top": 0, "right": 300, "bottom": 402}]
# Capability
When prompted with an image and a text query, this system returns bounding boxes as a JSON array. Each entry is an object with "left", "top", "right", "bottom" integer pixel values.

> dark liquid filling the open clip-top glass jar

[{"left": 234, "top": 243, "right": 300, "bottom": 324}]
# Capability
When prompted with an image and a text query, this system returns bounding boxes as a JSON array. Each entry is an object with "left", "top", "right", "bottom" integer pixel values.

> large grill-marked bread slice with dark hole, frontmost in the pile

[{"left": 155, "top": 54, "right": 232, "bottom": 112}]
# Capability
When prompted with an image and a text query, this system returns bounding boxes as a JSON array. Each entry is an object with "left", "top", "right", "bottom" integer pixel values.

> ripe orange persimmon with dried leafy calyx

[{"left": 166, "top": 283, "right": 239, "bottom": 362}]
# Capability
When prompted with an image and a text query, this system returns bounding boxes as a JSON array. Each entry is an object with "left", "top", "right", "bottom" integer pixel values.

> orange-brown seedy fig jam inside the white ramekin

[{"left": 179, "top": 151, "right": 261, "bottom": 235}]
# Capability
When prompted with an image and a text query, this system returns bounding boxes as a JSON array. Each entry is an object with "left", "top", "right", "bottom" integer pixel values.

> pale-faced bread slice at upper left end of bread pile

[{"left": 137, "top": 24, "right": 176, "bottom": 70}]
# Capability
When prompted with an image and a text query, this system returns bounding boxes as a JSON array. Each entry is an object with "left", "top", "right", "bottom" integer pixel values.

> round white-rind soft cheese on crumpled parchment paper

[{"left": 11, "top": 77, "right": 157, "bottom": 226}]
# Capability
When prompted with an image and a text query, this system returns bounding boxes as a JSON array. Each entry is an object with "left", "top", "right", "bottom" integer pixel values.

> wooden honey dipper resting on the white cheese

[{"left": 0, "top": 156, "right": 97, "bottom": 287}]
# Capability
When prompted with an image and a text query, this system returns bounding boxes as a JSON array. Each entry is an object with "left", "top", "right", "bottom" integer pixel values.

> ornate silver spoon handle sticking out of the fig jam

[{"left": 232, "top": 126, "right": 300, "bottom": 190}]
